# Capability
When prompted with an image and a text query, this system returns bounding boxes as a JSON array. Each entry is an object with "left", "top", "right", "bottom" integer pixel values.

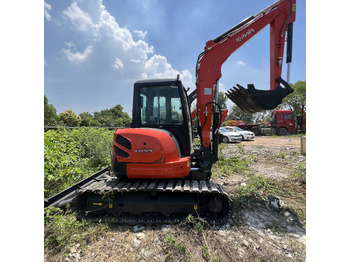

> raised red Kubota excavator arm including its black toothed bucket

[{"left": 196, "top": 0, "right": 296, "bottom": 147}]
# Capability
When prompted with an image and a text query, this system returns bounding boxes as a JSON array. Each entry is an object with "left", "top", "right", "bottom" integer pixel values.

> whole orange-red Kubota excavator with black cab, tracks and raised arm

[{"left": 45, "top": 0, "right": 296, "bottom": 224}]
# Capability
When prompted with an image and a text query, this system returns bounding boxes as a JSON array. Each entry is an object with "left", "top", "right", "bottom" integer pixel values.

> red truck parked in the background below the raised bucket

[{"left": 229, "top": 110, "right": 297, "bottom": 136}]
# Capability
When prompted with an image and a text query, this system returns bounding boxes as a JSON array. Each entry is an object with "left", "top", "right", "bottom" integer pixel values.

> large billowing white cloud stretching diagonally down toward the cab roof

[{"left": 58, "top": 0, "right": 194, "bottom": 87}]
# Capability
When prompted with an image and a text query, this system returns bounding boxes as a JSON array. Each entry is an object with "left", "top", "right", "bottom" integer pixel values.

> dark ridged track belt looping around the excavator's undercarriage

[{"left": 71, "top": 178, "right": 232, "bottom": 224}]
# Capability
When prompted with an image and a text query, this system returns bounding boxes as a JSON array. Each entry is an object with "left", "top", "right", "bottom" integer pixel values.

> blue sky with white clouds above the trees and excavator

[{"left": 44, "top": 0, "right": 306, "bottom": 115}]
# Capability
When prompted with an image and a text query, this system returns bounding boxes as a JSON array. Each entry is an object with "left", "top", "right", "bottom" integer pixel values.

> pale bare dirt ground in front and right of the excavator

[{"left": 45, "top": 136, "right": 306, "bottom": 262}]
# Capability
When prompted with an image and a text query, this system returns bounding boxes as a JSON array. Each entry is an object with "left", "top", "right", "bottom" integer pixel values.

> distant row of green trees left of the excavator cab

[{"left": 44, "top": 95, "right": 131, "bottom": 127}]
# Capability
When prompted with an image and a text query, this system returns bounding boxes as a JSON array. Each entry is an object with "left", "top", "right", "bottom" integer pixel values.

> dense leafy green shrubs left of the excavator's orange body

[{"left": 44, "top": 128, "right": 113, "bottom": 197}]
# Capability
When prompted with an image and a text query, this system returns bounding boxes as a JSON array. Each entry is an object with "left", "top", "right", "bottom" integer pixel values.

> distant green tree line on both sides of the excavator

[{"left": 44, "top": 81, "right": 306, "bottom": 129}]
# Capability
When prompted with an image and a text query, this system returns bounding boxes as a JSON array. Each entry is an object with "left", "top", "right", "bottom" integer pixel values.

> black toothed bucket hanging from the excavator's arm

[{"left": 226, "top": 77, "right": 294, "bottom": 113}]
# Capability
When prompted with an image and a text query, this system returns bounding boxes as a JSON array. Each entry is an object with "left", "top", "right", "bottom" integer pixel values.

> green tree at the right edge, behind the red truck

[{"left": 281, "top": 81, "right": 306, "bottom": 132}]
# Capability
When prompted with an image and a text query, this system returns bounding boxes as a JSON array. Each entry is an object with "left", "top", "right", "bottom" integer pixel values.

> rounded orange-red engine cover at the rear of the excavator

[{"left": 111, "top": 128, "right": 191, "bottom": 179}]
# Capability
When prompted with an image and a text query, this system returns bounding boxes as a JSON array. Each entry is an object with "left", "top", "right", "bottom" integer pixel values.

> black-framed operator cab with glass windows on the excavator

[{"left": 131, "top": 78, "right": 192, "bottom": 156}]
